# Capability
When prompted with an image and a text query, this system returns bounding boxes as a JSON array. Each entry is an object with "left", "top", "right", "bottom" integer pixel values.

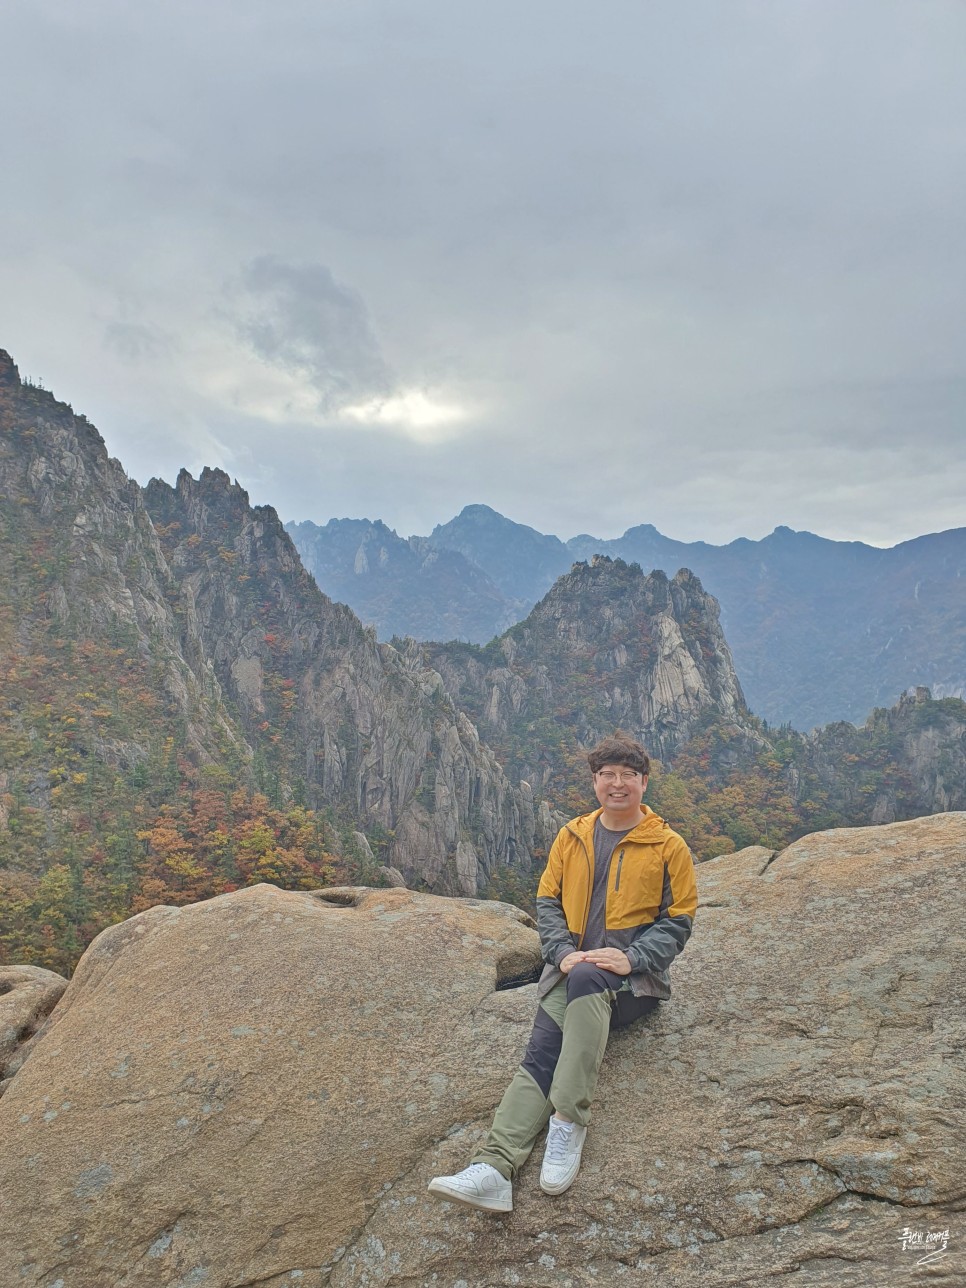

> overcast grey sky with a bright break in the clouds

[{"left": 0, "top": 0, "right": 966, "bottom": 545}]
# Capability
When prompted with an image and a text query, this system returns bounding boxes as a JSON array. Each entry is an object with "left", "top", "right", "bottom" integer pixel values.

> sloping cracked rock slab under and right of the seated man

[{"left": 331, "top": 814, "right": 966, "bottom": 1288}]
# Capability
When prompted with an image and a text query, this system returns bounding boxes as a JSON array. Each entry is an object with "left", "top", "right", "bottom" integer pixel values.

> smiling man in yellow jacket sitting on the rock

[{"left": 429, "top": 730, "right": 698, "bottom": 1212}]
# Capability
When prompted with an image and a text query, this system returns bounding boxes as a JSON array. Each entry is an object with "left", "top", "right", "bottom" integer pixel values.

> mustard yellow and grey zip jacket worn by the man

[{"left": 537, "top": 805, "right": 698, "bottom": 998}]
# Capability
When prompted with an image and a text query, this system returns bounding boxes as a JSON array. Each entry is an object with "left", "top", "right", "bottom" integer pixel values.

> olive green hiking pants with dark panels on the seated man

[{"left": 473, "top": 963, "right": 657, "bottom": 1181}]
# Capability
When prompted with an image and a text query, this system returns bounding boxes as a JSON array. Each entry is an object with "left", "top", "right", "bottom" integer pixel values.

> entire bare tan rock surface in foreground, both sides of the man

[{"left": 0, "top": 814, "right": 966, "bottom": 1288}]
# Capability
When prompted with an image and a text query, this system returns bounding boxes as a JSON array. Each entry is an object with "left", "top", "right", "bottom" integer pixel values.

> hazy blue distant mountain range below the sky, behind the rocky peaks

[{"left": 286, "top": 505, "right": 966, "bottom": 730}]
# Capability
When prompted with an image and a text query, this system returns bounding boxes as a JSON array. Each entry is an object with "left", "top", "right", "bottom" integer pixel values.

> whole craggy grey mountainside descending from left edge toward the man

[{"left": 0, "top": 354, "right": 533, "bottom": 927}]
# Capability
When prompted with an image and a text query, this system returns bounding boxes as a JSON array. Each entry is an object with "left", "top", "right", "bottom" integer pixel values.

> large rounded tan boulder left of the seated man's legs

[{"left": 0, "top": 885, "right": 538, "bottom": 1288}]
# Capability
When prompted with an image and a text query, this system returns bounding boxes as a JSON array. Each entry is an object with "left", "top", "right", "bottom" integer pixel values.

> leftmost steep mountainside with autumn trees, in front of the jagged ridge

[{"left": 0, "top": 353, "right": 250, "bottom": 965}]
